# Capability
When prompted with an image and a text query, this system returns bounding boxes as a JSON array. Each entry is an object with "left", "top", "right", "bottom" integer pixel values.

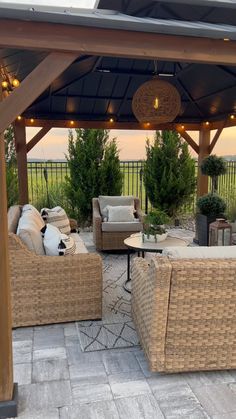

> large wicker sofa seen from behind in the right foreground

[{"left": 132, "top": 246, "right": 236, "bottom": 372}]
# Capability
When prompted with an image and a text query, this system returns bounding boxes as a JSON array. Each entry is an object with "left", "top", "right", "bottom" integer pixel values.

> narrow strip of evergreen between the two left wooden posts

[{"left": 4, "top": 125, "right": 18, "bottom": 207}]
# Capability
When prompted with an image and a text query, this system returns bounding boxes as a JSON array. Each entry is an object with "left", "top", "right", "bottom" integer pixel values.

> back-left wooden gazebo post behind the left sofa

[{"left": 14, "top": 123, "right": 29, "bottom": 205}]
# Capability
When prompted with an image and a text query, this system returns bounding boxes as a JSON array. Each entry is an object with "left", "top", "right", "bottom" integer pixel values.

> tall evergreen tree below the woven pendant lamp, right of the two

[{"left": 144, "top": 131, "right": 196, "bottom": 217}]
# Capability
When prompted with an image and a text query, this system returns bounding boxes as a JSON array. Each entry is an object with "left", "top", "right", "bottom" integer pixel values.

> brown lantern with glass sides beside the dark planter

[{"left": 209, "top": 218, "right": 232, "bottom": 246}]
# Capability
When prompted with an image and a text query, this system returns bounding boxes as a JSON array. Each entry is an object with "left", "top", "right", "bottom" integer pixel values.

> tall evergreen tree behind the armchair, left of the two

[{"left": 66, "top": 129, "right": 121, "bottom": 221}]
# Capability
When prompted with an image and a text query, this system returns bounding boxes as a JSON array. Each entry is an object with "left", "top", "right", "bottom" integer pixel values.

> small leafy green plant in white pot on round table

[{"left": 143, "top": 209, "right": 170, "bottom": 243}]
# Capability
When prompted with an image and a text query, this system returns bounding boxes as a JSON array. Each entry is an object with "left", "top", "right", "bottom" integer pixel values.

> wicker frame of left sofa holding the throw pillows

[{"left": 8, "top": 206, "right": 102, "bottom": 327}]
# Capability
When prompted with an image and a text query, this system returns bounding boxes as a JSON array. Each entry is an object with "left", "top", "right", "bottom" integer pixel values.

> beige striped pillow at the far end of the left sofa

[{"left": 41, "top": 207, "right": 70, "bottom": 234}]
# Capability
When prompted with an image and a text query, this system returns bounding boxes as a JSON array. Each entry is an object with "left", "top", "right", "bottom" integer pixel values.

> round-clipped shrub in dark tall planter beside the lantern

[{"left": 196, "top": 193, "right": 226, "bottom": 246}]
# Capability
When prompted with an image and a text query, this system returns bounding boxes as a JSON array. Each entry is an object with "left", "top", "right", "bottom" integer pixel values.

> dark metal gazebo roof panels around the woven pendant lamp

[{"left": 0, "top": 0, "right": 236, "bottom": 123}]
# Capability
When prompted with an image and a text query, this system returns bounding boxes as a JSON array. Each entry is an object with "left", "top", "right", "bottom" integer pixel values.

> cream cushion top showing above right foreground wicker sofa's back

[{"left": 162, "top": 246, "right": 236, "bottom": 259}]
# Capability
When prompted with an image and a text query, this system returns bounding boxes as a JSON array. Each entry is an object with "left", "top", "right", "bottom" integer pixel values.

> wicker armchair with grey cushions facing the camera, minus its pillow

[{"left": 92, "top": 196, "right": 144, "bottom": 250}]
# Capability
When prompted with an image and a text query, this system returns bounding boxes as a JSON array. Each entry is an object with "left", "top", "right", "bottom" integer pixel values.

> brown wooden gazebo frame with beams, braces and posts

[{"left": 0, "top": 2, "right": 236, "bottom": 416}]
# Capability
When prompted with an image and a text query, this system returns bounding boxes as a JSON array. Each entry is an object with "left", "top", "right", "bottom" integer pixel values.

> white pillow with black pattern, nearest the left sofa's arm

[{"left": 41, "top": 224, "right": 76, "bottom": 256}]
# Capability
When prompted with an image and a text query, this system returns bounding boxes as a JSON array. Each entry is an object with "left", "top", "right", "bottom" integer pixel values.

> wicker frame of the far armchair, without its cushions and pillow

[{"left": 92, "top": 198, "right": 144, "bottom": 250}]
